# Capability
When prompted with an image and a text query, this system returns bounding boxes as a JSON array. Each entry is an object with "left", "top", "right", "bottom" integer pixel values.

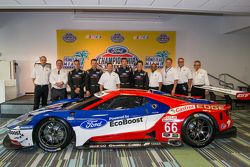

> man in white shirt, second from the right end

[{"left": 176, "top": 58, "right": 192, "bottom": 96}]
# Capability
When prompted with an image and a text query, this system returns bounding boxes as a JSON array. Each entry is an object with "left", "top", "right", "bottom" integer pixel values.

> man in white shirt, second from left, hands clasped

[{"left": 49, "top": 59, "right": 68, "bottom": 101}]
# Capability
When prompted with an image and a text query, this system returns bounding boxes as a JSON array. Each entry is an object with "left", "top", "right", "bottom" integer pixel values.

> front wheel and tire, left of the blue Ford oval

[{"left": 34, "top": 118, "right": 73, "bottom": 152}]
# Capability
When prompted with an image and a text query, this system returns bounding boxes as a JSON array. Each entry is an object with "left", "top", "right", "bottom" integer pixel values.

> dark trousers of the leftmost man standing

[{"left": 33, "top": 85, "right": 49, "bottom": 110}]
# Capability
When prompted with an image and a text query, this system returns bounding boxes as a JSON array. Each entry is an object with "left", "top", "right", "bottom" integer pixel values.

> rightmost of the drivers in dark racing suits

[{"left": 134, "top": 60, "right": 149, "bottom": 89}]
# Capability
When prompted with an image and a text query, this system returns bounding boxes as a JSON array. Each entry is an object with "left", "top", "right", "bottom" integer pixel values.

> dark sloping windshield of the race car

[{"left": 65, "top": 96, "right": 101, "bottom": 110}]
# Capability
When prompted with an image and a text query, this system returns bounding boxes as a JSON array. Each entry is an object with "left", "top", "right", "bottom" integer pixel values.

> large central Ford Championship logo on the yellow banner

[{"left": 96, "top": 45, "right": 139, "bottom": 68}]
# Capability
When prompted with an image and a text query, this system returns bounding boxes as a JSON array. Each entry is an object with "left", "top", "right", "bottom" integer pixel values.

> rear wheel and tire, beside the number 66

[{"left": 182, "top": 113, "right": 215, "bottom": 148}]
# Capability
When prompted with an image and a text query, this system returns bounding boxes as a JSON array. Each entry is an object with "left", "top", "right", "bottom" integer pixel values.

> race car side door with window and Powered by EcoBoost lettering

[{"left": 90, "top": 95, "right": 147, "bottom": 134}]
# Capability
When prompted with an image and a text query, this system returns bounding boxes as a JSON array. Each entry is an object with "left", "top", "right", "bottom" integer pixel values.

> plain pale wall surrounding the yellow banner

[{"left": 0, "top": 12, "right": 250, "bottom": 94}]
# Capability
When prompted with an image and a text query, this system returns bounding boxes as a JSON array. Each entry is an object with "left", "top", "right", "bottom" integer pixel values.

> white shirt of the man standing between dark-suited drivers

[{"left": 98, "top": 71, "right": 121, "bottom": 90}]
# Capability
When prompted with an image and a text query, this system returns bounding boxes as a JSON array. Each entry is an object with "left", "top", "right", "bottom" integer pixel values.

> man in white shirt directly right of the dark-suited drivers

[{"left": 149, "top": 63, "right": 162, "bottom": 90}]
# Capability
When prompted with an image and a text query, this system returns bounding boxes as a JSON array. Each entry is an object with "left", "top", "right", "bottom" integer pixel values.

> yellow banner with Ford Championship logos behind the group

[{"left": 57, "top": 30, "right": 176, "bottom": 70}]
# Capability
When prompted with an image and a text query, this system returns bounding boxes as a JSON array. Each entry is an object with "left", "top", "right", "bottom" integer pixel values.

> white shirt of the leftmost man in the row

[{"left": 31, "top": 65, "right": 50, "bottom": 85}]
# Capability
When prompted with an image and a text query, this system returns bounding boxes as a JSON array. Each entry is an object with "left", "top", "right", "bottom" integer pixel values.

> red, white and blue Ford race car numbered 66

[{"left": 3, "top": 89, "right": 236, "bottom": 152}]
